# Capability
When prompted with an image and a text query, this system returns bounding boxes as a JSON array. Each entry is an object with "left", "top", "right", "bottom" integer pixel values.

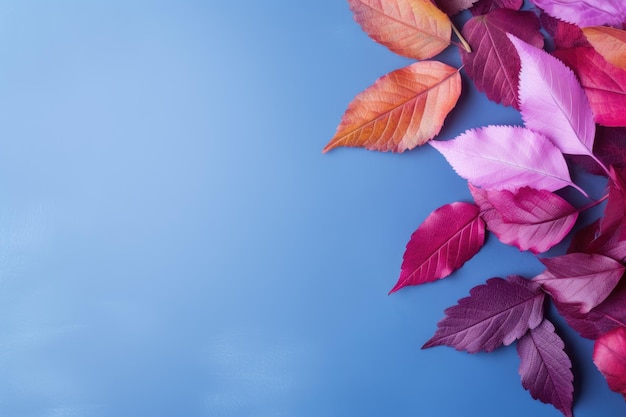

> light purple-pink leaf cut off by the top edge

[{"left": 531, "top": 0, "right": 626, "bottom": 27}]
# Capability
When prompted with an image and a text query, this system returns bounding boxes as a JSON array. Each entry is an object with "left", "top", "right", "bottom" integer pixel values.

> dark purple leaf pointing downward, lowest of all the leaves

[{"left": 517, "top": 320, "right": 574, "bottom": 417}]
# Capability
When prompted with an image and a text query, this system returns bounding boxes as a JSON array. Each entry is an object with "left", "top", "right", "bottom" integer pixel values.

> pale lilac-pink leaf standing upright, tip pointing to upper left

[{"left": 509, "top": 35, "right": 596, "bottom": 155}]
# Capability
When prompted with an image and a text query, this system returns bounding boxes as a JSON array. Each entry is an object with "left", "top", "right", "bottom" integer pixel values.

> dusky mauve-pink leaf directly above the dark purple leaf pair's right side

[{"left": 533, "top": 253, "right": 626, "bottom": 313}]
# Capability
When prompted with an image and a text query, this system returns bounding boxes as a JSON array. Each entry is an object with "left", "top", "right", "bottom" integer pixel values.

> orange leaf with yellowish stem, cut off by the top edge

[{"left": 348, "top": 0, "right": 452, "bottom": 59}]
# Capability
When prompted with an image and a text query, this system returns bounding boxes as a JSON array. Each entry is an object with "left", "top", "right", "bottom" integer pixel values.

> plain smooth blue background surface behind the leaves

[{"left": 0, "top": 0, "right": 624, "bottom": 417}]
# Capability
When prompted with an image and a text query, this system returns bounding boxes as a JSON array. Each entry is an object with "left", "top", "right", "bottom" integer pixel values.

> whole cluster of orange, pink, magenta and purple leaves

[{"left": 324, "top": 0, "right": 626, "bottom": 416}]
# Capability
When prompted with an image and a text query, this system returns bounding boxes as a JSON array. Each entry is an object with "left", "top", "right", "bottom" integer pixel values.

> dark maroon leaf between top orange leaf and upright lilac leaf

[{"left": 461, "top": 9, "right": 543, "bottom": 109}]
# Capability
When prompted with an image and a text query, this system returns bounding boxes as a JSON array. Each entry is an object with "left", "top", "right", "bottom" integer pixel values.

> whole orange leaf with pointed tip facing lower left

[{"left": 323, "top": 61, "right": 461, "bottom": 152}]
